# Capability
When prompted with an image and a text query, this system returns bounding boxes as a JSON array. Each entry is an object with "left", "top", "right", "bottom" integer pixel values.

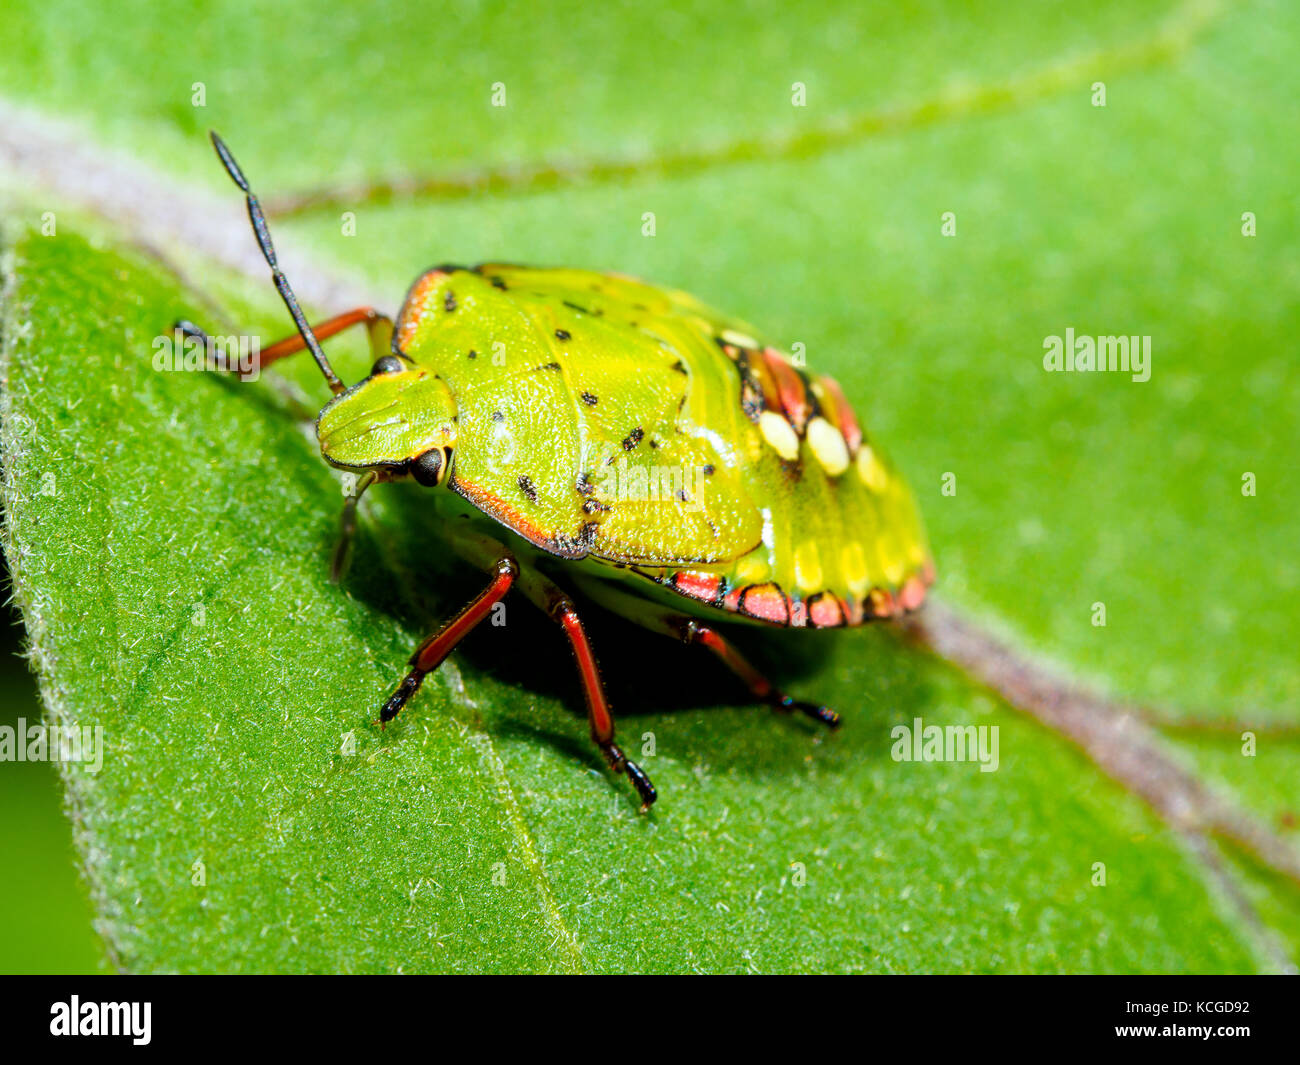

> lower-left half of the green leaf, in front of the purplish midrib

[{"left": 4, "top": 224, "right": 1279, "bottom": 971}]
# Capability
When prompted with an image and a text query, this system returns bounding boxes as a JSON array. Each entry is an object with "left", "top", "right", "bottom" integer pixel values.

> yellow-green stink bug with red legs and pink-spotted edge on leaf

[{"left": 178, "top": 133, "right": 933, "bottom": 809}]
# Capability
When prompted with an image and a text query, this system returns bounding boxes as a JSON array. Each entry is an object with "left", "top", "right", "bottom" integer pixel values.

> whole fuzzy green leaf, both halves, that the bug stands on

[{"left": 0, "top": 3, "right": 1300, "bottom": 971}]
